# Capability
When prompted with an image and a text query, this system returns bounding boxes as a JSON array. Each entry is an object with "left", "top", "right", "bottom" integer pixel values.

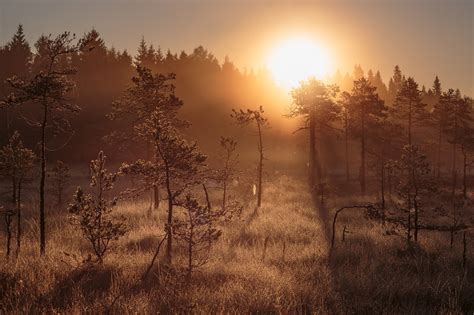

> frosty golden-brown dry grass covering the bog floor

[{"left": 0, "top": 176, "right": 474, "bottom": 314}]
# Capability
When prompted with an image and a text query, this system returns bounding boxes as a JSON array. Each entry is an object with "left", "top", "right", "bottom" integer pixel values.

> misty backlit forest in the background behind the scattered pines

[{"left": 0, "top": 25, "right": 452, "bottom": 170}]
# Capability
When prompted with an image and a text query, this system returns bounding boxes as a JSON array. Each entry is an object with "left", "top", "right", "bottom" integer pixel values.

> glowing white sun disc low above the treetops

[{"left": 267, "top": 37, "right": 332, "bottom": 89}]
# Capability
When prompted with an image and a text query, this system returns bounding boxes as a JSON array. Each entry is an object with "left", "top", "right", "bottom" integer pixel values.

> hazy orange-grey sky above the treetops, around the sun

[{"left": 0, "top": 0, "right": 474, "bottom": 95}]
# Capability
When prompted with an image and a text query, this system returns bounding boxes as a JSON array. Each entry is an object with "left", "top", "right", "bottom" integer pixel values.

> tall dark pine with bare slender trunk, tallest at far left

[{"left": 3, "top": 32, "right": 87, "bottom": 255}]
